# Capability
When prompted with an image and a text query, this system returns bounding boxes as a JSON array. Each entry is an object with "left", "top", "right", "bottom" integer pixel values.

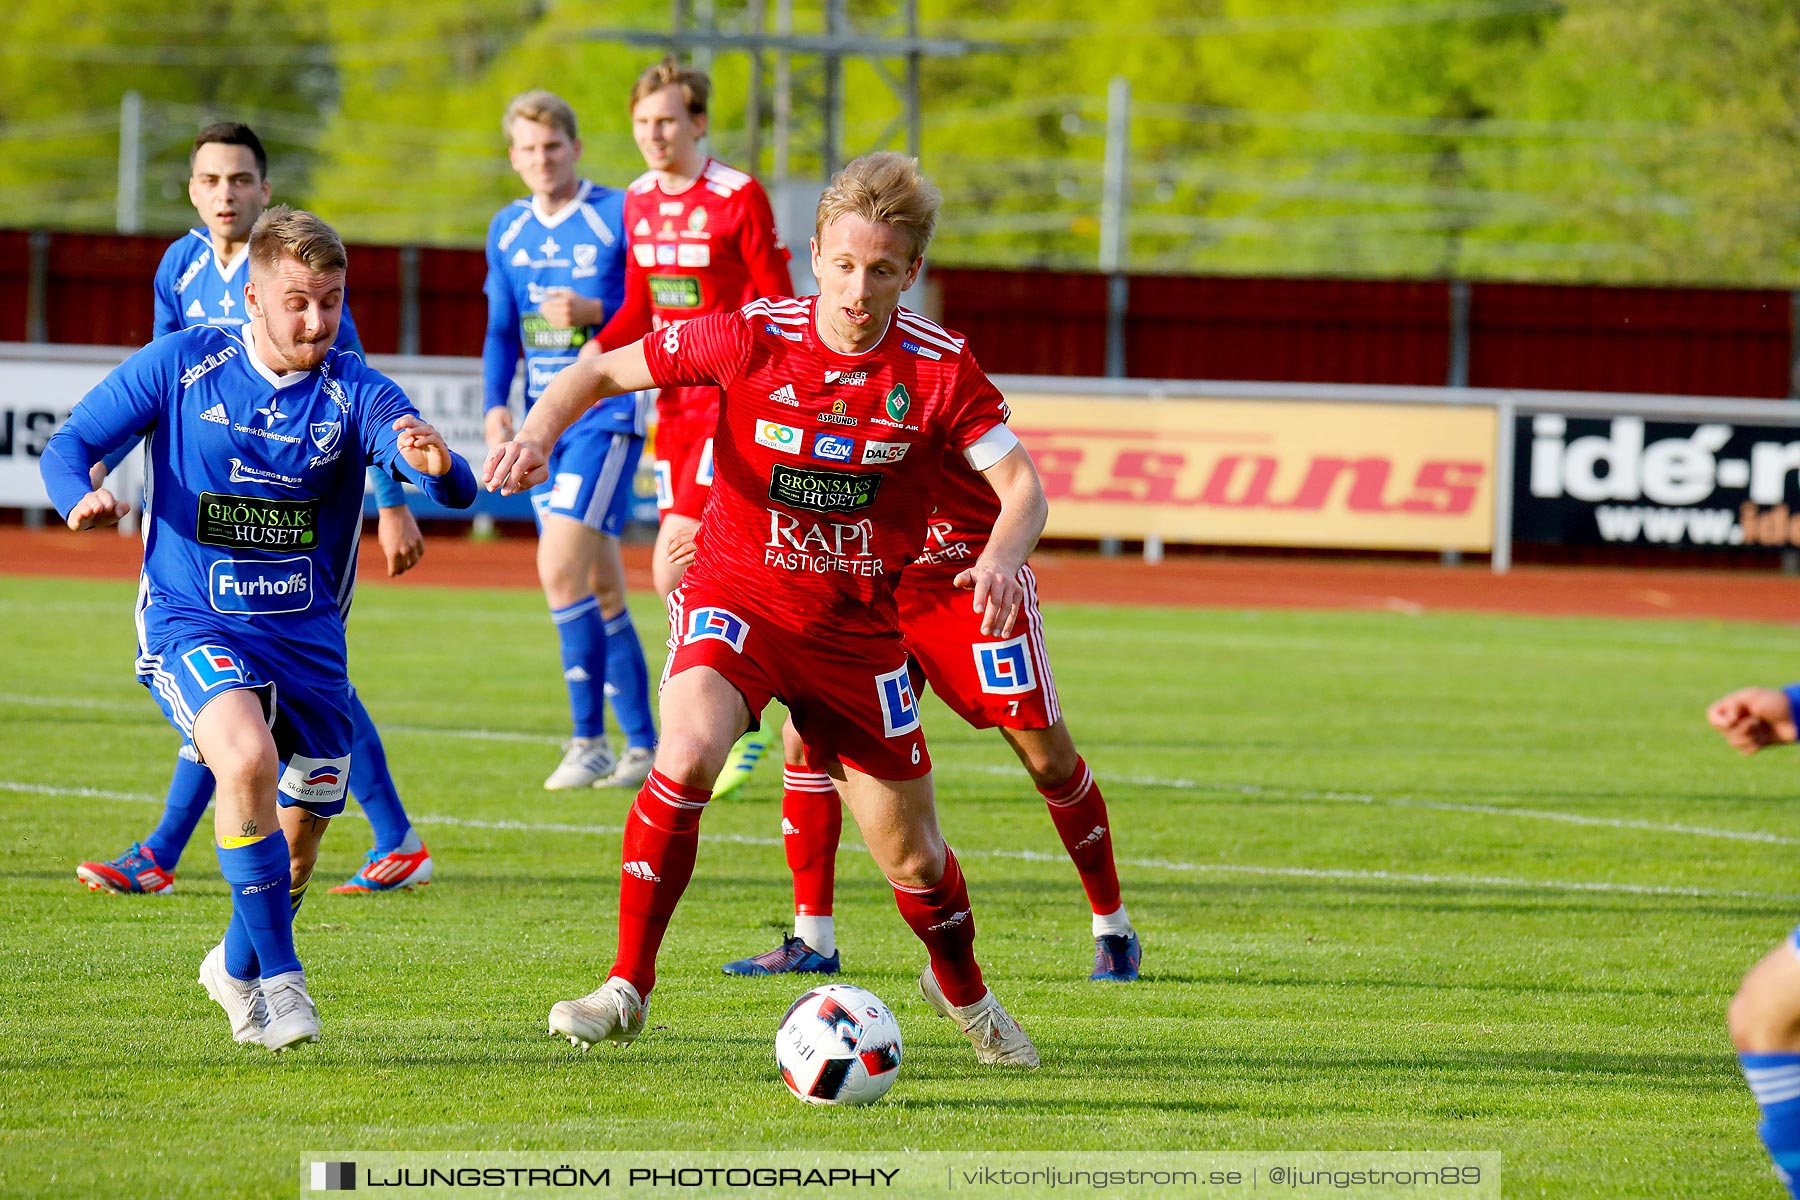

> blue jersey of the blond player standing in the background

[{"left": 482, "top": 180, "right": 646, "bottom": 435}]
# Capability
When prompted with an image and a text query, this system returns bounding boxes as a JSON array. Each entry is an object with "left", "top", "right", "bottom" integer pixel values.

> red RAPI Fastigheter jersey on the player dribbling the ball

[{"left": 644, "top": 297, "right": 1006, "bottom": 637}]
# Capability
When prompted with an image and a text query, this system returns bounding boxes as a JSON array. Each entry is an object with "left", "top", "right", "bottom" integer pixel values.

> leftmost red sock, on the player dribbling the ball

[{"left": 610, "top": 770, "right": 713, "bottom": 995}]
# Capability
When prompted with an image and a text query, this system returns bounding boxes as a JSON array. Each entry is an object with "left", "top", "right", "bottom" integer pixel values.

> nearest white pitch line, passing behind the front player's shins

[{"left": 0, "top": 779, "right": 1800, "bottom": 905}]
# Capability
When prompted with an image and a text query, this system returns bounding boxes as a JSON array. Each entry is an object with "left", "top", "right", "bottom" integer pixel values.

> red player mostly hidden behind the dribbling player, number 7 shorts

[{"left": 702, "top": 453, "right": 1143, "bottom": 982}]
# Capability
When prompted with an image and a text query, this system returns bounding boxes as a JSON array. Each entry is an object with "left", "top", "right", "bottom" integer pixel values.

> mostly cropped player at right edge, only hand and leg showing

[{"left": 1706, "top": 684, "right": 1800, "bottom": 1200}]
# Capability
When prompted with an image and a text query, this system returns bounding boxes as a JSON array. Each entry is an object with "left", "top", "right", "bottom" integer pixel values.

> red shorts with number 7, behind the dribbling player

[{"left": 896, "top": 565, "right": 1062, "bottom": 729}]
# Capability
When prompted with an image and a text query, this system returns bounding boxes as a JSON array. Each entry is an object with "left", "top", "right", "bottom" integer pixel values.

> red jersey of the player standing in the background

[{"left": 598, "top": 158, "right": 794, "bottom": 421}]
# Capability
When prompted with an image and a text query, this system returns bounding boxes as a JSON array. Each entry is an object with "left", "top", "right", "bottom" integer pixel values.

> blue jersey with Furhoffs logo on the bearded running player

[{"left": 43, "top": 326, "right": 475, "bottom": 671}]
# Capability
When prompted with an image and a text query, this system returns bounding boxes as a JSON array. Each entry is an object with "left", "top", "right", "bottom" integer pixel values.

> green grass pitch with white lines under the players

[{"left": 0, "top": 578, "right": 1800, "bottom": 1200}]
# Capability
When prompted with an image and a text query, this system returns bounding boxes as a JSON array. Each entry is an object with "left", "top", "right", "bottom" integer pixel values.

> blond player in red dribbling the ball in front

[{"left": 482, "top": 153, "right": 1046, "bottom": 1067}]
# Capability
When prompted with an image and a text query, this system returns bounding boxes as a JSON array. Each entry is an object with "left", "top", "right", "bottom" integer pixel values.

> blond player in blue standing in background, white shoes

[{"left": 481, "top": 92, "right": 657, "bottom": 792}]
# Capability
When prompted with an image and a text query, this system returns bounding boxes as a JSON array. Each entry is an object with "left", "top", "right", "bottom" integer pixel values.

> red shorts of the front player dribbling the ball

[{"left": 662, "top": 587, "right": 936, "bottom": 779}]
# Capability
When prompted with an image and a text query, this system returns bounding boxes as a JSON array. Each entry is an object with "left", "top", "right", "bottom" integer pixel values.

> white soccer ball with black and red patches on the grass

[{"left": 776, "top": 984, "right": 900, "bottom": 1105}]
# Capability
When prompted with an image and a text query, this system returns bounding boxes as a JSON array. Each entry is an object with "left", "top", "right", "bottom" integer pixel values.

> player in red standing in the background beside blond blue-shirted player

[{"left": 596, "top": 58, "right": 794, "bottom": 597}]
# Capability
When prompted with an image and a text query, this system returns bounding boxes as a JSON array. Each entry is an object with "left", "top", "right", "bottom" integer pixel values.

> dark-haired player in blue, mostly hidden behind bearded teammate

[{"left": 76, "top": 122, "right": 442, "bottom": 894}]
